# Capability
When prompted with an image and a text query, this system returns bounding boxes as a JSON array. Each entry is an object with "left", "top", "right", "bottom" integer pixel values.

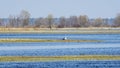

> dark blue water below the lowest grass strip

[{"left": 0, "top": 60, "right": 120, "bottom": 68}]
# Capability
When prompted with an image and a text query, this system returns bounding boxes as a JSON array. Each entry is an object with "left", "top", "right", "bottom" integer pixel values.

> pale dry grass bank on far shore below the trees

[{"left": 0, "top": 27, "right": 120, "bottom": 34}]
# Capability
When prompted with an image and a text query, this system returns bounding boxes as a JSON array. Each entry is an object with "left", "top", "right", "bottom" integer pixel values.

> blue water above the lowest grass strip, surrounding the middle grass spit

[{"left": 0, "top": 34, "right": 120, "bottom": 56}]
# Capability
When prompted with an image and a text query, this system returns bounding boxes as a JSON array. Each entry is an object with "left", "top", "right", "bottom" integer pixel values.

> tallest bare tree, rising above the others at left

[{"left": 19, "top": 10, "right": 30, "bottom": 27}]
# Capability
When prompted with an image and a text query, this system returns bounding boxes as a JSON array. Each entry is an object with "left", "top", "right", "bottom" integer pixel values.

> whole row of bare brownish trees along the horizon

[{"left": 0, "top": 10, "right": 120, "bottom": 29}]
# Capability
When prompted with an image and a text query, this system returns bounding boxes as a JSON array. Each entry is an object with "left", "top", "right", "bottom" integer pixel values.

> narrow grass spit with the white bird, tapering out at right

[{"left": 0, "top": 39, "right": 102, "bottom": 42}]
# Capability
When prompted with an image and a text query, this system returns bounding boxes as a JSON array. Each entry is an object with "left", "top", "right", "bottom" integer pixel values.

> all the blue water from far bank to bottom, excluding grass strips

[{"left": 0, "top": 34, "right": 120, "bottom": 68}]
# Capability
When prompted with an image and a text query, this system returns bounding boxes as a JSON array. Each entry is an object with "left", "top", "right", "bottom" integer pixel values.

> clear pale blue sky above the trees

[{"left": 0, "top": 0, "right": 120, "bottom": 18}]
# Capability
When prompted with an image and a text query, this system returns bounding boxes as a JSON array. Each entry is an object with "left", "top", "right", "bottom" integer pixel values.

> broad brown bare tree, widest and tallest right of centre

[{"left": 78, "top": 15, "right": 89, "bottom": 27}]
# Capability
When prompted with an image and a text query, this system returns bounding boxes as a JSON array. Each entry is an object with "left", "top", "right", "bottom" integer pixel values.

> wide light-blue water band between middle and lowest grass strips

[{"left": 0, "top": 43, "right": 120, "bottom": 56}]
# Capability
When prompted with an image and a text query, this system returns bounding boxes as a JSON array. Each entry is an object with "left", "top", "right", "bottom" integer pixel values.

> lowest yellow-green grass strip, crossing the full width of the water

[{"left": 0, "top": 55, "right": 120, "bottom": 62}]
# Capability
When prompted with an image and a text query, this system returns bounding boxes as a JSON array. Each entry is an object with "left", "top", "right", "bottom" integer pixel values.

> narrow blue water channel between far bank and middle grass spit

[{"left": 0, "top": 33, "right": 120, "bottom": 43}]
